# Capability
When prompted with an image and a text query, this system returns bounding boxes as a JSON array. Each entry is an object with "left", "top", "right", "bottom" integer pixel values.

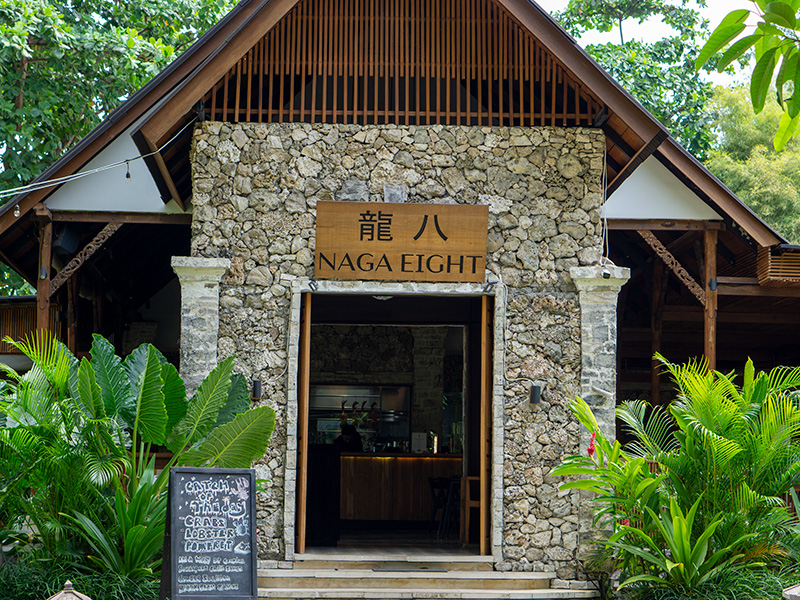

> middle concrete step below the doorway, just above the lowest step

[{"left": 258, "top": 565, "right": 556, "bottom": 591}]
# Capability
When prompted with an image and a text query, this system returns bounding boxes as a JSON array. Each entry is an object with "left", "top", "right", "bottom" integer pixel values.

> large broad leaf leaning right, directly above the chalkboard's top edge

[{"left": 180, "top": 406, "right": 275, "bottom": 468}]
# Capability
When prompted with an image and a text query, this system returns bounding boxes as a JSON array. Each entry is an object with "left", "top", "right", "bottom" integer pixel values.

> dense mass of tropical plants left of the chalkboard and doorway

[{"left": 0, "top": 332, "right": 275, "bottom": 578}]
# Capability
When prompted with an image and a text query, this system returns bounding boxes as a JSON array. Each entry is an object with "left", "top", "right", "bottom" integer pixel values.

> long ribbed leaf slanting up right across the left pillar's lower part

[{"left": 167, "top": 357, "right": 233, "bottom": 453}]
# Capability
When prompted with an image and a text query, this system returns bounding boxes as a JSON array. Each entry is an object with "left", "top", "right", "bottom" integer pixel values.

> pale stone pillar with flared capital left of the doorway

[{"left": 172, "top": 256, "right": 231, "bottom": 395}]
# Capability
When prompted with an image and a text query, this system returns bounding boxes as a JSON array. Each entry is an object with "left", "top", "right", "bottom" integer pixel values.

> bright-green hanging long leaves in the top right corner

[{"left": 696, "top": 0, "right": 800, "bottom": 150}]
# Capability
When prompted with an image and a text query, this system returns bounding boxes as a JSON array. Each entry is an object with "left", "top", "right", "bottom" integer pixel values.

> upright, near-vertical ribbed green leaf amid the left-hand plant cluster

[{"left": 125, "top": 345, "right": 167, "bottom": 444}]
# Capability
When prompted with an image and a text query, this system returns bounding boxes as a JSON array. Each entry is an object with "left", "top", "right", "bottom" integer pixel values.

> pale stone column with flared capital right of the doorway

[{"left": 570, "top": 266, "right": 631, "bottom": 559}]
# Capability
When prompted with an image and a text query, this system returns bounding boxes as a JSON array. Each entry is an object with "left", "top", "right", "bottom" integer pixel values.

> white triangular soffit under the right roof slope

[{"left": 605, "top": 156, "right": 722, "bottom": 221}]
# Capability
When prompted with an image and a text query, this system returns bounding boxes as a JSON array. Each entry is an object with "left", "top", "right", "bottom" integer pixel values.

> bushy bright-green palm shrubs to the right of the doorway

[{"left": 554, "top": 356, "right": 800, "bottom": 593}]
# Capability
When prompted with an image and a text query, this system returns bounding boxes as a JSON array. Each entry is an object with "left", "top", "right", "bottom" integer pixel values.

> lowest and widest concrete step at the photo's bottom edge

[{"left": 258, "top": 587, "right": 598, "bottom": 600}]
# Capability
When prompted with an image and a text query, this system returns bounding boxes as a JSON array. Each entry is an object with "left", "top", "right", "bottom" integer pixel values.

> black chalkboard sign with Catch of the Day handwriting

[{"left": 164, "top": 467, "right": 258, "bottom": 600}]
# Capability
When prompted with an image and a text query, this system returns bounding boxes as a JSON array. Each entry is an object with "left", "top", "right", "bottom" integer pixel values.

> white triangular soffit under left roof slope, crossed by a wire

[{"left": 45, "top": 130, "right": 181, "bottom": 213}]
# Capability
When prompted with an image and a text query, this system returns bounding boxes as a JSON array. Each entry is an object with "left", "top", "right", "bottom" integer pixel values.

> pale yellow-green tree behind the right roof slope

[{"left": 706, "top": 87, "right": 800, "bottom": 243}]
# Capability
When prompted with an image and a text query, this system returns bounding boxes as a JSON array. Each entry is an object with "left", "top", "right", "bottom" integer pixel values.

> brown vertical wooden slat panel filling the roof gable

[{"left": 204, "top": 0, "right": 600, "bottom": 126}]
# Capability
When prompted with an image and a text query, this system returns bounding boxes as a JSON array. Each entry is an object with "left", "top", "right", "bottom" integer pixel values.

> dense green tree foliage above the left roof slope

[{"left": 0, "top": 0, "right": 233, "bottom": 188}]
